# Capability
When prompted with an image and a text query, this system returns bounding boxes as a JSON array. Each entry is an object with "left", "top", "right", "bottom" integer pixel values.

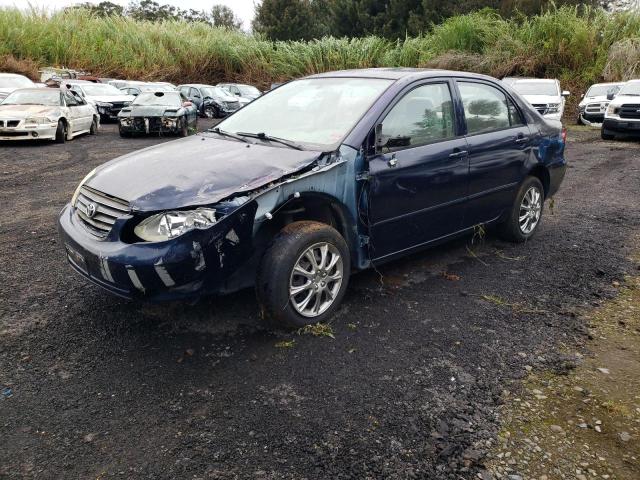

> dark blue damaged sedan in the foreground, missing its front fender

[{"left": 58, "top": 69, "right": 566, "bottom": 327}]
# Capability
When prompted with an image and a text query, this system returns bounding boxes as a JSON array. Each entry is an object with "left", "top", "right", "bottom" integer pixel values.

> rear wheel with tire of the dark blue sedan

[{"left": 499, "top": 177, "right": 544, "bottom": 243}]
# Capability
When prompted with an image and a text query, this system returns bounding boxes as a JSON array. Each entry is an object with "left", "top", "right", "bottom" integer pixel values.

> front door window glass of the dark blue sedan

[{"left": 381, "top": 83, "right": 455, "bottom": 151}]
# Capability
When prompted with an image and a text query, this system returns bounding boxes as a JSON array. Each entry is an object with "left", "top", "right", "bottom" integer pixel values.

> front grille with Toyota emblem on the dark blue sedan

[{"left": 75, "top": 186, "right": 129, "bottom": 237}]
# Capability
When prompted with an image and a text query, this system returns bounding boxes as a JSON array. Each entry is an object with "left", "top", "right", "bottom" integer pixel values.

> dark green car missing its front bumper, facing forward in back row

[{"left": 118, "top": 91, "right": 198, "bottom": 137}]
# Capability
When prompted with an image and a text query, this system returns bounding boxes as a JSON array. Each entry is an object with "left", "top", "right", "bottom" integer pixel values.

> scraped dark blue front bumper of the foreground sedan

[{"left": 58, "top": 202, "right": 257, "bottom": 301}]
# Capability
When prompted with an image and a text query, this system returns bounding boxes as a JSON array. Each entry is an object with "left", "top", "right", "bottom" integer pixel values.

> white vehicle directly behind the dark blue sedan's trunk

[{"left": 507, "top": 78, "right": 570, "bottom": 120}]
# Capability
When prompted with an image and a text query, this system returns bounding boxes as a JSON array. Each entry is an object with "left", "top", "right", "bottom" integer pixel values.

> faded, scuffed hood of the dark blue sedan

[{"left": 86, "top": 134, "right": 322, "bottom": 212}]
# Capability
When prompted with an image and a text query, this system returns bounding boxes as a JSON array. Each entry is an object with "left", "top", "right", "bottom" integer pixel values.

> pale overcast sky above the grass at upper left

[{"left": 0, "top": 0, "right": 254, "bottom": 30}]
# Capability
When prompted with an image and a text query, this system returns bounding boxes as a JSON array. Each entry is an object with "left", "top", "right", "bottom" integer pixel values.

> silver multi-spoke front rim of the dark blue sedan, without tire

[{"left": 289, "top": 242, "right": 344, "bottom": 318}]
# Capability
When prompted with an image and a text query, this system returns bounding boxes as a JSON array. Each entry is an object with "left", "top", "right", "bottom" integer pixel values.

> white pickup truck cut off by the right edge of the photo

[{"left": 602, "top": 80, "right": 640, "bottom": 140}]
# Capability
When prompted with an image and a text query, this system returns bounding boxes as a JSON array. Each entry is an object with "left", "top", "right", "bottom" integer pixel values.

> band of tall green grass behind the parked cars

[{"left": 0, "top": 7, "right": 640, "bottom": 90}]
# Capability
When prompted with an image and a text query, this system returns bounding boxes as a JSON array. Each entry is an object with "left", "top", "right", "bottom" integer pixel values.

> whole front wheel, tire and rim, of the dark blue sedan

[{"left": 256, "top": 221, "right": 351, "bottom": 328}]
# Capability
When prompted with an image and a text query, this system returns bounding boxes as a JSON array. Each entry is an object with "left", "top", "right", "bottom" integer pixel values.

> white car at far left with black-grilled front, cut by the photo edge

[{"left": 0, "top": 88, "right": 100, "bottom": 143}]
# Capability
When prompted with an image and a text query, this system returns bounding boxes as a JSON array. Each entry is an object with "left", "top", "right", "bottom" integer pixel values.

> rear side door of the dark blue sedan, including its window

[{"left": 457, "top": 79, "right": 532, "bottom": 228}]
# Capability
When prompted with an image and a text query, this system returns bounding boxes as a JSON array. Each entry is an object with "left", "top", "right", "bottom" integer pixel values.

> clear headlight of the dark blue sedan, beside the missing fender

[{"left": 133, "top": 208, "right": 216, "bottom": 242}]
